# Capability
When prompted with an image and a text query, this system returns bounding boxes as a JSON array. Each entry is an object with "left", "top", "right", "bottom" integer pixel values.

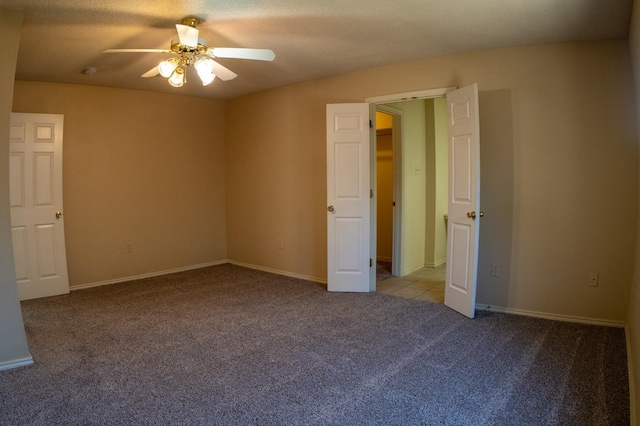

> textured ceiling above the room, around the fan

[{"left": 0, "top": 0, "right": 632, "bottom": 99}]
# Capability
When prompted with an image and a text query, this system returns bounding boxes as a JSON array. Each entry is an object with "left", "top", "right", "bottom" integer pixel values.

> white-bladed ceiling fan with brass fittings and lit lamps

[{"left": 102, "top": 17, "right": 276, "bottom": 87}]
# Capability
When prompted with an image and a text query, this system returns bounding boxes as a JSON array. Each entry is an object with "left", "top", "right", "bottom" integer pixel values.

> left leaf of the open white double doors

[{"left": 327, "top": 103, "right": 372, "bottom": 292}]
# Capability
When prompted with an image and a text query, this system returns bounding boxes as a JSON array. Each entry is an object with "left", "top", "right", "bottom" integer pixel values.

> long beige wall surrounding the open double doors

[{"left": 226, "top": 41, "right": 638, "bottom": 321}]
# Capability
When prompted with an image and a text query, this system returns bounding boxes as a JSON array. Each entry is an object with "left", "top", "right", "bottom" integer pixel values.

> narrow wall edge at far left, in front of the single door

[{"left": 0, "top": 8, "right": 31, "bottom": 369}]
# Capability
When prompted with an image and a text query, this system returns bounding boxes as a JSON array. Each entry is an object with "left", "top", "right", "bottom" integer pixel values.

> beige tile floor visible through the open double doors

[{"left": 377, "top": 265, "right": 447, "bottom": 303}]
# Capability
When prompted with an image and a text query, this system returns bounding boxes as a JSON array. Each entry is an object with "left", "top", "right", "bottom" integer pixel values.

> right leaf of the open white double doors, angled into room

[{"left": 444, "top": 84, "right": 480, "bottom": 318}]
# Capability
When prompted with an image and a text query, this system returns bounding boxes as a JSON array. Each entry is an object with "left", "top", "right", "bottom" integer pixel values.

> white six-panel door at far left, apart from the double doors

[{"left": 9, "top": 113, "right": 69, "bottom": 300}]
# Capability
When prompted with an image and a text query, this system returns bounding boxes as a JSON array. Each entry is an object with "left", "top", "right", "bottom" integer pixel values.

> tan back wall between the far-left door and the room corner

[{"left": 13, "top": 81, "right": 226, "bottom": 286}]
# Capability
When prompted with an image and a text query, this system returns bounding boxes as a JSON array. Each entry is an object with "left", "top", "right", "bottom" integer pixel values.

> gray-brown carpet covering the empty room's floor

[{"left": 0, "top": 265, "right": 629, "bottom": 425}]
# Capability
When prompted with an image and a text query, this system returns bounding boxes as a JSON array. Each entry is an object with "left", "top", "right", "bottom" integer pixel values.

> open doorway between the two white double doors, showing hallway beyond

[{"left": 375, "top": 96, "right": 448, "bottom": 303}]
